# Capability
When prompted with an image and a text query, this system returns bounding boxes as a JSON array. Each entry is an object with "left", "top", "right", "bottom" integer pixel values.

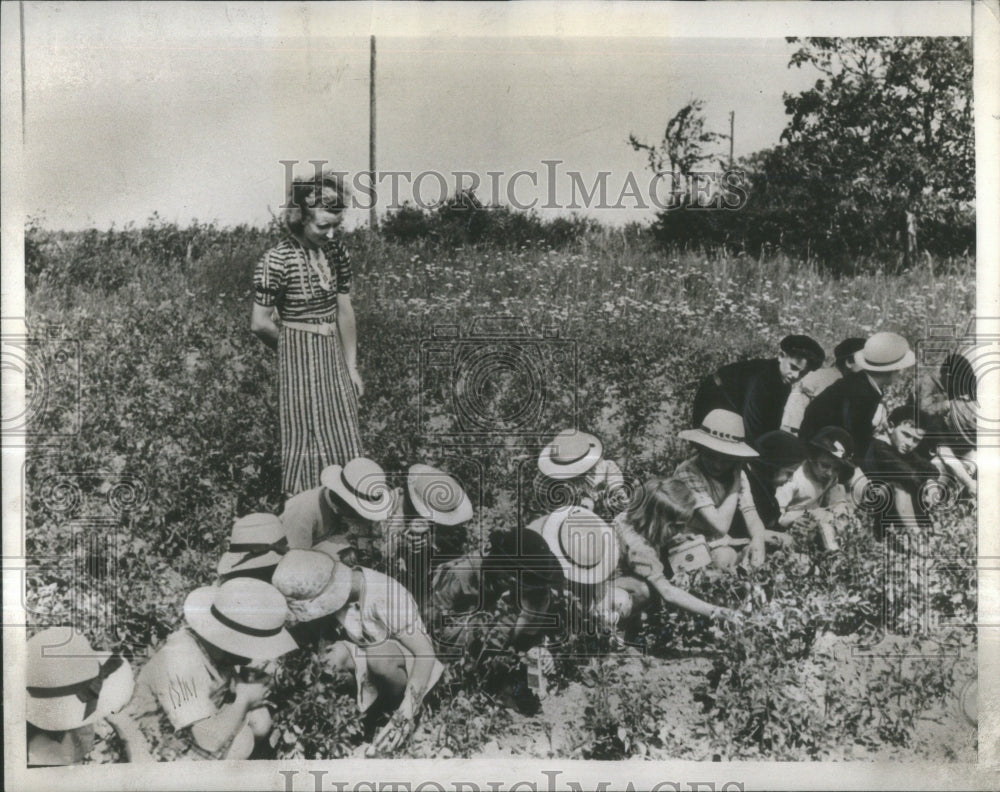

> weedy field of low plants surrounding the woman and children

[{"left": 25, "top": 218, "right": 976, "bottom": 761}]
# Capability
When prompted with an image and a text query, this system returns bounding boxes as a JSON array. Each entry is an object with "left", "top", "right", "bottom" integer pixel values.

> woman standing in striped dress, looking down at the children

[{"left": 251, "top": 173, "right": 364, "bottom": 497}]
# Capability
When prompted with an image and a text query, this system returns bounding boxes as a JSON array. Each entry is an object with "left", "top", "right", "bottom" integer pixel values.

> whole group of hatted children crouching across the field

[{"left": 27, "top": 333, "right": 976, "bottom": 765}]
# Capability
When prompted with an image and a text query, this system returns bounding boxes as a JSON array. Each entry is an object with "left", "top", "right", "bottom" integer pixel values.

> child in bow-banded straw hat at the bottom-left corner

[{"left": 25, "top": 627, "right": 141, "bottom": 767}]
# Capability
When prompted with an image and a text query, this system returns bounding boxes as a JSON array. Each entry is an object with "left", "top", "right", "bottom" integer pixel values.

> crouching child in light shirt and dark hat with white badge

[{"left": 774, "top": 426, "right": 854, "bottom": 550}]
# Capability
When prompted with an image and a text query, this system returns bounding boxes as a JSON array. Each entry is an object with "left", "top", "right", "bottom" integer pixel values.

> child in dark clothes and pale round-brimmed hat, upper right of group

[{"left": 799, "top": 333, "right": 916, "bottom": 459}]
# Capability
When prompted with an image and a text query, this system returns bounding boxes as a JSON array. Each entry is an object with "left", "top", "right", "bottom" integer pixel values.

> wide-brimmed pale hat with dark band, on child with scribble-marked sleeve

[{"left": 184, "top": 577, "right": 298, "bottom": 660}]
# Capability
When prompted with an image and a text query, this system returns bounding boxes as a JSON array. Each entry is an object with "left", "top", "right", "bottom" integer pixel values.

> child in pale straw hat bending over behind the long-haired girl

[{"left": 535, "top": 429, "right": 628, "bottom": 516}]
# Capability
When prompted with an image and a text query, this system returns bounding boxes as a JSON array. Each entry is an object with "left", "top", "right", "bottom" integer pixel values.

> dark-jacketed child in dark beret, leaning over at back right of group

[{"left": 691, "top": 335, "right": 826, "bottom": 446}]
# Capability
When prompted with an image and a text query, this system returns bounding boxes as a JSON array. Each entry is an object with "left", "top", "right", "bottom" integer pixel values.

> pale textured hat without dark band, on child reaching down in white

[{"left": 271, "top": 545, "right": 353, "bottom": 622}]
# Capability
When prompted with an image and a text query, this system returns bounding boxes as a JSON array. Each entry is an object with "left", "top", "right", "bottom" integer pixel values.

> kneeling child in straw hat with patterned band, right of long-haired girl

[{"left": 674, "top": 410, "right": 766, "bottom": 567}]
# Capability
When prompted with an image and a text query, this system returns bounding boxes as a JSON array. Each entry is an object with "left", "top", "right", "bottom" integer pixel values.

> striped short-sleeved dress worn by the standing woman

[{"left": 254, "top": 239, "right": 362, "bottom": 496}]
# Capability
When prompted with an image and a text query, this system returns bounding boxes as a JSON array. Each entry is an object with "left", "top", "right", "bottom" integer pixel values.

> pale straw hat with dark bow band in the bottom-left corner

[{"left": 25, "top": 627, "right": 135, "bottom": 731}]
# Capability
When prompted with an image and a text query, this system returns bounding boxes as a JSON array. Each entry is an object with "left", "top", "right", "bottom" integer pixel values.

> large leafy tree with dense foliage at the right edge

[{"left": 780, "top": 37, "right": 975, "bottom": 263}]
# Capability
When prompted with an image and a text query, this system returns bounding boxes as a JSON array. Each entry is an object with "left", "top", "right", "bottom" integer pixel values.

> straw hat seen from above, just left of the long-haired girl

[{"left": 541, "top": 506, "right": 619, "bottom": 584}]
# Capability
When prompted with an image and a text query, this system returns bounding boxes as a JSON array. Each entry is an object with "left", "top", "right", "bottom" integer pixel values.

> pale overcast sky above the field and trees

[{"left": 15, "top": 3, "right": 968, "bottom": 228}]
